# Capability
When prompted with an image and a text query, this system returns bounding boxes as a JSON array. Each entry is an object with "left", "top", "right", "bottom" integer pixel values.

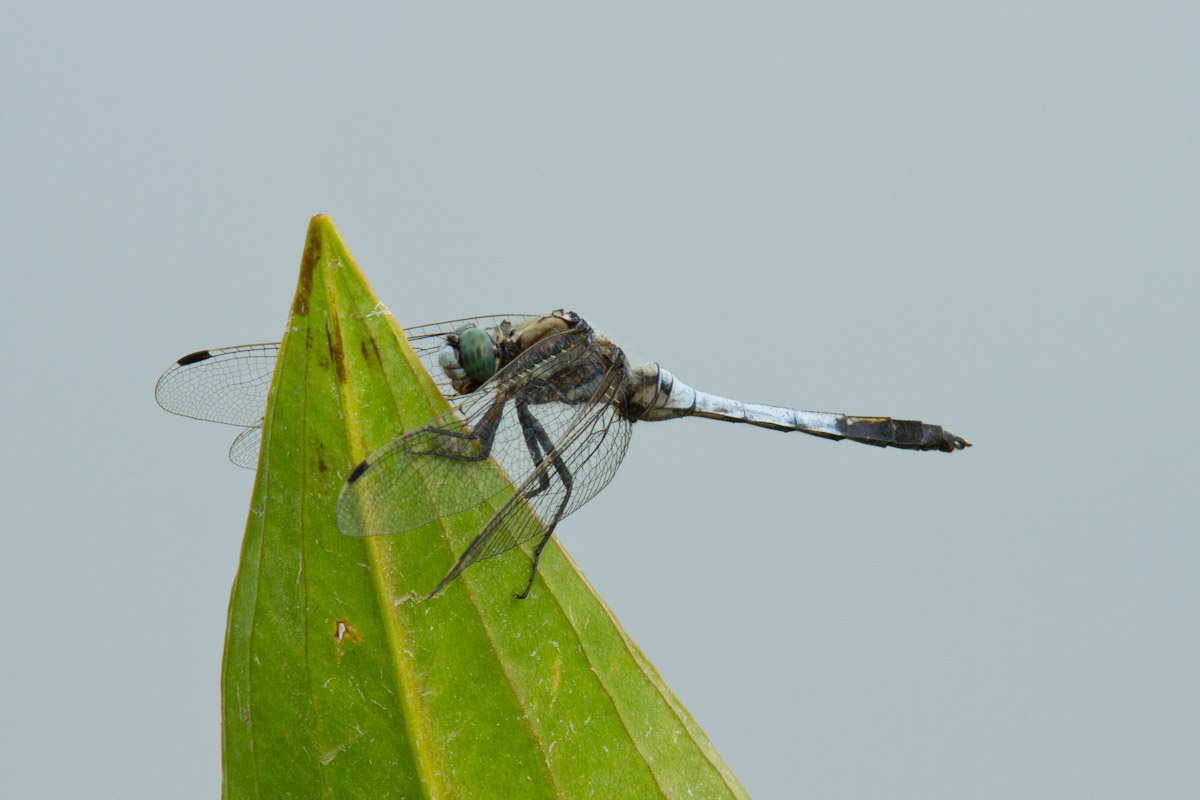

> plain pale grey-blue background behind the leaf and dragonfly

[{"left": 0, "top": 2, "right": 1200, "bottom": 798}]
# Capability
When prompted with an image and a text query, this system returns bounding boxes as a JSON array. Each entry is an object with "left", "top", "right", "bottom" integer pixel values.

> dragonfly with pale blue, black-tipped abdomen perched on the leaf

[{"left": 155, "top": 309, "right": 971, "bottom": 600}]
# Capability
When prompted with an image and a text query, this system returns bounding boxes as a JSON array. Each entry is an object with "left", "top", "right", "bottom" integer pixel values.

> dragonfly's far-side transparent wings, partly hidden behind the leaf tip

[{"left": 155, "top": 314, "right": 530, "bottom": 469}]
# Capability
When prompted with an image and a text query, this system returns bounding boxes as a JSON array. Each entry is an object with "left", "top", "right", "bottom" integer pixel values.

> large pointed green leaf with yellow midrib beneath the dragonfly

[{"left": 222, "top": 216, "right": 745, "bottom": 800}]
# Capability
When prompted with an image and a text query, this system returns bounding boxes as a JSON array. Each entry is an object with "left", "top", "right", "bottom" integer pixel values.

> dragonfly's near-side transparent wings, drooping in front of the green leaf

[{"left": 337, "top": 331, "right": 629, "bottom": 556}]
